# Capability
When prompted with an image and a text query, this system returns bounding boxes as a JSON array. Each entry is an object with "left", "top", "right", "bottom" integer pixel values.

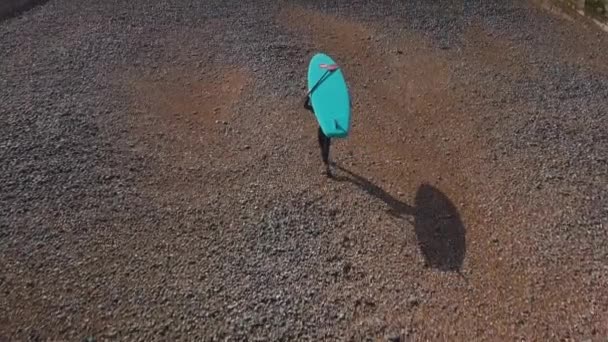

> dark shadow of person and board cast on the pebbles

[{"left": 334, "top": 164, "right": 466, "bottom": 272}]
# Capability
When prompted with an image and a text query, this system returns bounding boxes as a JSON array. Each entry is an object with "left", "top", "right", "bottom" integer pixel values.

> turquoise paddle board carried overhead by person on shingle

[{"left": 308, "top": 53, "right": 350, "bottom": 138}]
